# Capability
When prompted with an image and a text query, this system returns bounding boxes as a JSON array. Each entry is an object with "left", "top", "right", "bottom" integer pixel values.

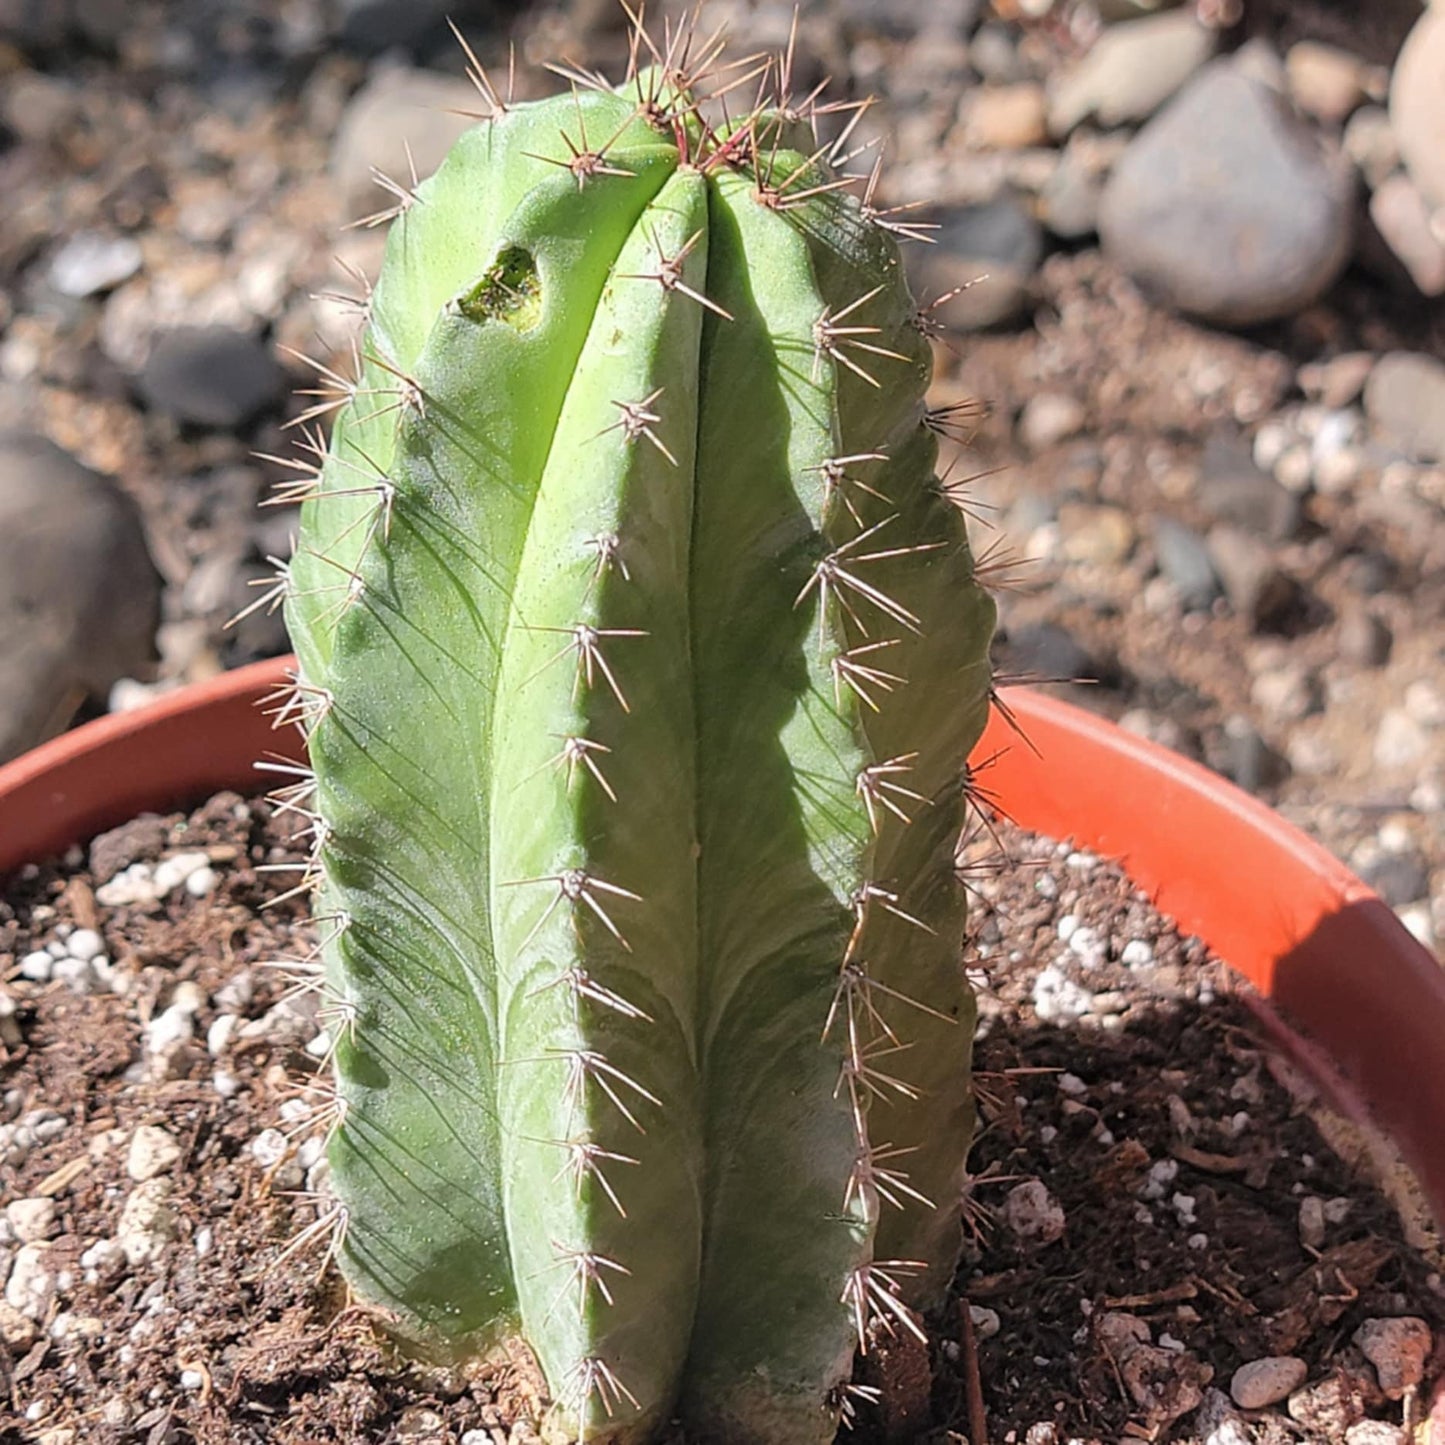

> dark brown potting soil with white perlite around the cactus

[{"left": 0, "top": 795, "right": 1445, "bottom": 1445}]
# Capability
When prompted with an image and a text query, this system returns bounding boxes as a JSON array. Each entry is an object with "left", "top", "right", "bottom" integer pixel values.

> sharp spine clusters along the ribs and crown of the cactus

[{"left": 238, "top": 0, "right": 1001, "bottom": 1433}]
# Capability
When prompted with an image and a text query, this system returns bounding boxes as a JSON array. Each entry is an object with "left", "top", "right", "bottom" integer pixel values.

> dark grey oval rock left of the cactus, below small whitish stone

[{"left": 139, "top": 327, "right": 286, "bottom": 431}]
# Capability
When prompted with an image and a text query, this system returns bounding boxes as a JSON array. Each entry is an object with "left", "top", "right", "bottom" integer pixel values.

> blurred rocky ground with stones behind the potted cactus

[{"left": 0, "top": 0, "right": 1445, "bottom": 948}]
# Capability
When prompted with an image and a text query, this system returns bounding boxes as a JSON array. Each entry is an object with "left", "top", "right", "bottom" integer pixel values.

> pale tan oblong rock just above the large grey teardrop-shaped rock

[{"left": 1049, "top": 9, "right": 1215, "bottom": 136}]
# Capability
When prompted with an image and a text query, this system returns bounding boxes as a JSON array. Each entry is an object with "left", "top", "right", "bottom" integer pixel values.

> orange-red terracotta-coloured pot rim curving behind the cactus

[{"left": 0, "top": 659, "right": 1445, "bottom": 1221}]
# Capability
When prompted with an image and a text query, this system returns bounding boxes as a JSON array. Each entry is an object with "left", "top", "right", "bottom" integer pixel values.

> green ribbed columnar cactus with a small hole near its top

[{"left": 277, "top": 14, "right": 993, "bottom": 1441}]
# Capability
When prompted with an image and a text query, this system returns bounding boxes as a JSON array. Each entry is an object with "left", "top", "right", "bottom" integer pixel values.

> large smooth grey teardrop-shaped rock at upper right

[{"left": 1100, "top": 61, "right": 1355, "bottom": 327}]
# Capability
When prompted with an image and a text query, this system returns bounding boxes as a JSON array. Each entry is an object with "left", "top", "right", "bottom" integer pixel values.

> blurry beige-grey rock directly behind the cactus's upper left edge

[{"left": 331, "top": 66, "right": 484, "bottom": 217}]
